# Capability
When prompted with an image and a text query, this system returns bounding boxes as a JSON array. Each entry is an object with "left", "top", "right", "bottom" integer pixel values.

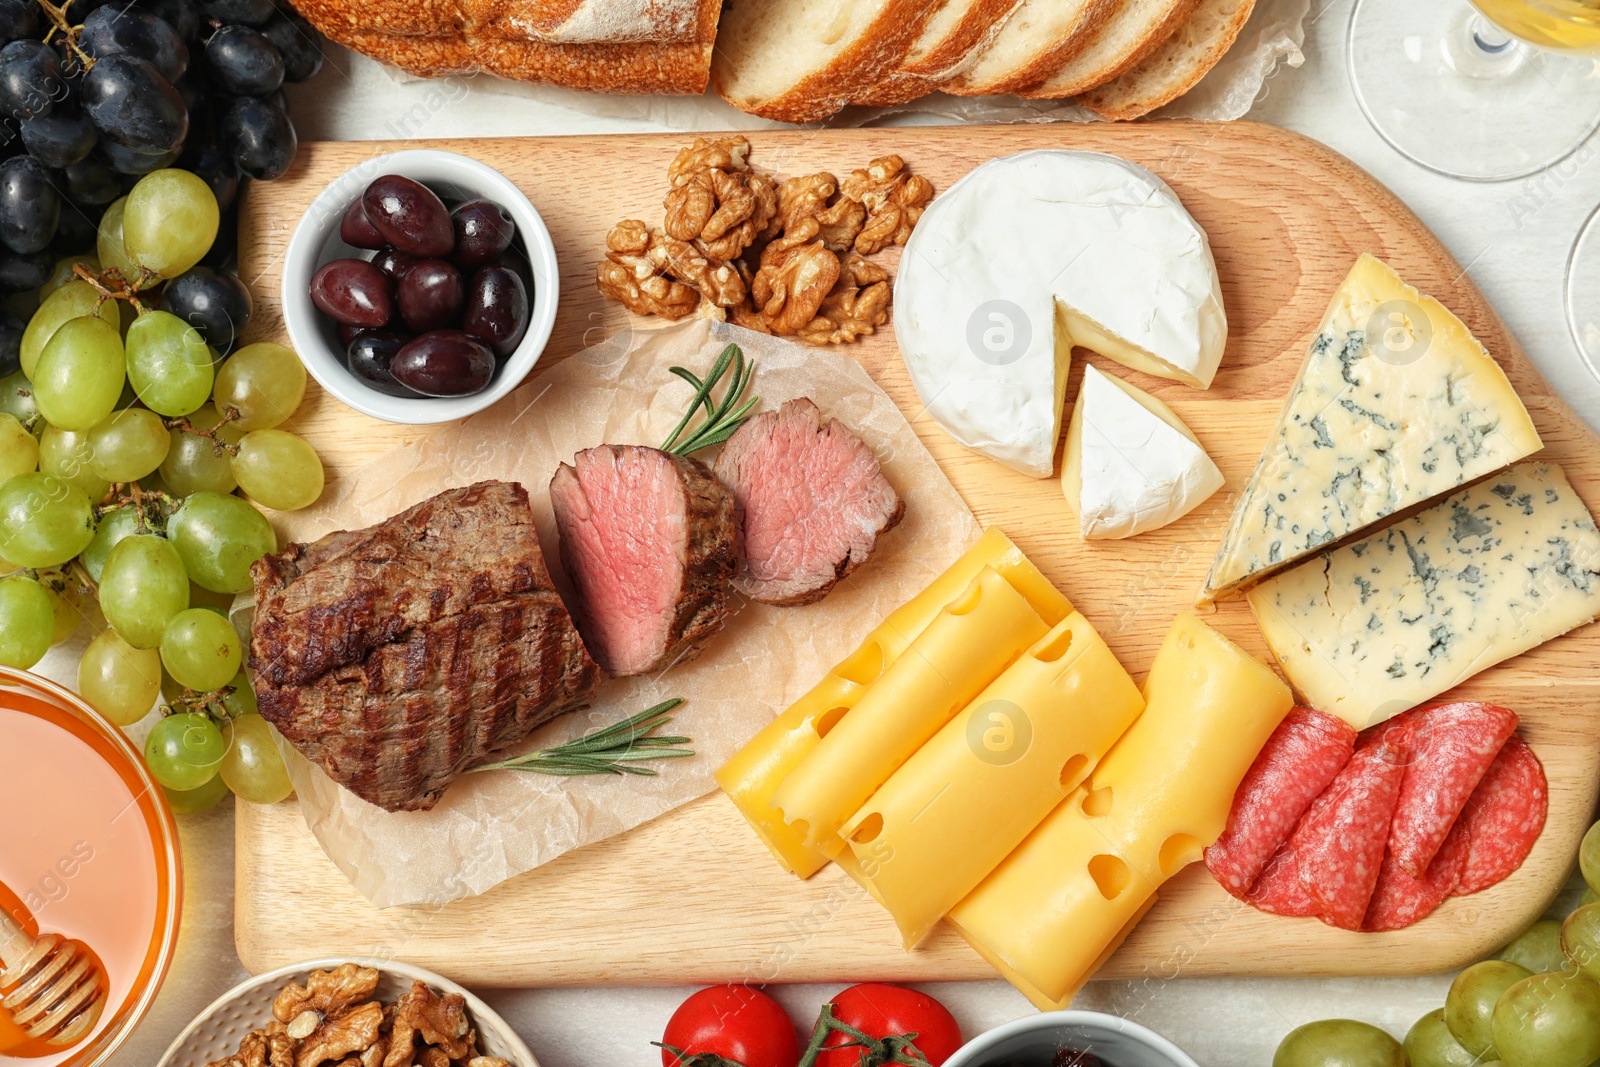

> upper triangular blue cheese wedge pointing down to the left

[{"left": 1200, "top": 256, "right": 1542, "bottom": 603}]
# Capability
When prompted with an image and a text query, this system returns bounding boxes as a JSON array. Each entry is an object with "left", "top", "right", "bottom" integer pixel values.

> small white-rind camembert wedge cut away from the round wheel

[{"left": 1061, "top": 366, "right": 1222, "bottom": 537}]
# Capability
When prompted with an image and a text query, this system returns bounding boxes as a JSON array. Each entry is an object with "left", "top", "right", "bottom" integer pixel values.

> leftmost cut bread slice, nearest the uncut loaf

[{"left": 710, "top": 0, "right": 939, "bottom": 123}]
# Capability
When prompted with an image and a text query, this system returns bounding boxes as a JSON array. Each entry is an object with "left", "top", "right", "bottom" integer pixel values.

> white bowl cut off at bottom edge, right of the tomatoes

[{"left": 944, "top": 1011, "right": 1200, "bottom": 1067}]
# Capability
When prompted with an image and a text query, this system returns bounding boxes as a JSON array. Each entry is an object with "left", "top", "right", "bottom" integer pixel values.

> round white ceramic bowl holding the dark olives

[{"left": 282, "top": 149, "right": 562, "bottom": 426}]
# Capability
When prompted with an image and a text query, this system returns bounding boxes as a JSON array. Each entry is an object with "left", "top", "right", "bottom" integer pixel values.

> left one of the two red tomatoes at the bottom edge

[{"left": 661, "top": 985, "right": 800, "bottom": 1067}]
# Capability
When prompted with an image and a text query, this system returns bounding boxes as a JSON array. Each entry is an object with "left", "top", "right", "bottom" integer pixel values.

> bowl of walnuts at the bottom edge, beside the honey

[{"left": 157, "top": 957, "right": 539, "bottom": 1067}]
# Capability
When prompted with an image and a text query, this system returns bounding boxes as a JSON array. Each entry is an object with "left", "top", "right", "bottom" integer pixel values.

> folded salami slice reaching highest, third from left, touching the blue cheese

[{"left": 1386, "top": 704, "right": 1517, "bottom": 880}]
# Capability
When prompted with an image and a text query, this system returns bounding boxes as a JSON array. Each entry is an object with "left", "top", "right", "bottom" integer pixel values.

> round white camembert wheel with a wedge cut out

[{"left": 894, "top": 149, "right": 1227, "bottom": 478}]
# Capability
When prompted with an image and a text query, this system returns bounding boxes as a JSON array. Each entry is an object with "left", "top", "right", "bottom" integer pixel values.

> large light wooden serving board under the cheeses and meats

[{"left": 235, "top": 123, "right": 1600, "bottom": 985}]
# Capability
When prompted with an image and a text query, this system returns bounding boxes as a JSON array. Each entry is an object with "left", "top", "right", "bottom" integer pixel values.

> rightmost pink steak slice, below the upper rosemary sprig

[{"left": 717, "top": 397, "right": 906, "bottom": 605}]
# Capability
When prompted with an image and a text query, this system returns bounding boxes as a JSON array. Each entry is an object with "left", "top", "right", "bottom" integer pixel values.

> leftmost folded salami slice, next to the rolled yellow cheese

[{"left": 1205, "top": 707, "right": 1355, "bottom": 910}]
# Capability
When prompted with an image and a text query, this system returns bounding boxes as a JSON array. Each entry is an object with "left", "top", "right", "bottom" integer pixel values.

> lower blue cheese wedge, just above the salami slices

[{"left": 1246, "top": 464, "right": 1600, "bottom": 729}]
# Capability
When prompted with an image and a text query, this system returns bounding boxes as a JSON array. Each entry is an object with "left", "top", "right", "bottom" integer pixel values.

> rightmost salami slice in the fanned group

[{"left": 1456, "top": 734, "right": 1550, "bottom": 896}]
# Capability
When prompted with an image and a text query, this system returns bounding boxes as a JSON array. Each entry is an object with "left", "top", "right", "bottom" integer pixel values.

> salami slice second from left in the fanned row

[{"left": 1288, "top": 742, "right": 1405, "bottom": 929}]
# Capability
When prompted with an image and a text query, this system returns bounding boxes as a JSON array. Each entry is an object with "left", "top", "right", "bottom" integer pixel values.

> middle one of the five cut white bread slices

[{"left": 941, "top": 0, "right": 1133, "bottom": 96}]
